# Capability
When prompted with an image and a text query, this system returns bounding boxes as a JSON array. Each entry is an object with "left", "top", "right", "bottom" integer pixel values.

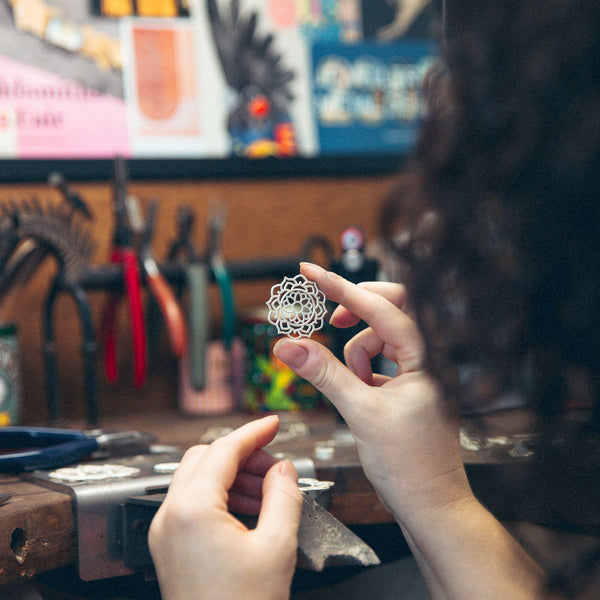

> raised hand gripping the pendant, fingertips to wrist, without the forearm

[{"left": 274, "top": 263, "right": 471, "bottom": 524}]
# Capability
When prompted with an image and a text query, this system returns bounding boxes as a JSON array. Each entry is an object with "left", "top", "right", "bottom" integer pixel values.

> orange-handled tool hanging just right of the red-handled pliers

[{"left": 139, "top": 201, "right": 187, "bottom": 358}]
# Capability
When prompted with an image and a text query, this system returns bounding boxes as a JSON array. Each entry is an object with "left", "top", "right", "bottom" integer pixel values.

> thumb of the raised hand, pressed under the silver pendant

[{"left": 273, "top": 338, "right": 367, "bottom": 417}]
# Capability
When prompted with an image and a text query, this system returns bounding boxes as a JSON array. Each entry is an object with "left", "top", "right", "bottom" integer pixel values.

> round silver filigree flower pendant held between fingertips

[{"left": 267, "top": 275, "right": 327, "bottom": 338}]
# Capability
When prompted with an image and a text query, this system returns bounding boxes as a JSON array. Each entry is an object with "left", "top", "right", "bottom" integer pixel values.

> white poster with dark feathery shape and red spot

[{"left": 193, "top": 0, "right": 324, "bottom": 158}]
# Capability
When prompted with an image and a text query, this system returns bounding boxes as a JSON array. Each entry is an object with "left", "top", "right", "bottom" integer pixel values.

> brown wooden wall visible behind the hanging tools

[{"left": 0, "top": 177, "right": 398, "bottom": 423}]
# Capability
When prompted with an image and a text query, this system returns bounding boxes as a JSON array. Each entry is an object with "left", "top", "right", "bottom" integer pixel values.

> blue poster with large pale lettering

[{"left": 312, "top": 40, "right": 436, "bottom": 154}]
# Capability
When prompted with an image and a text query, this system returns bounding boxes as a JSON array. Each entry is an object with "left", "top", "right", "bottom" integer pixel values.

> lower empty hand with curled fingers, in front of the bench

[{"left": 148, "top": 416, "right": 302, "bottom": 600}]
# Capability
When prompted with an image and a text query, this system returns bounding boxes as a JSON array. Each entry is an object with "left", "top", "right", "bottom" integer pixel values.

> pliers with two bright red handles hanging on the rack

[{"left": 102, "top": 157, "right": 146, "bottom": 387}]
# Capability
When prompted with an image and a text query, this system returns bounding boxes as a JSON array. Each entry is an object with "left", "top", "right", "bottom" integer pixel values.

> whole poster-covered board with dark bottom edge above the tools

[{"left": 0, "top": 0, "right": 443, "bottom": 182}]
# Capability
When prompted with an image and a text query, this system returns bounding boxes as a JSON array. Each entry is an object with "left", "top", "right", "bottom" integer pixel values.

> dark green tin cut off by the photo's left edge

[{"left": 0, "top": 323, "right": 21, "bottom": 426}]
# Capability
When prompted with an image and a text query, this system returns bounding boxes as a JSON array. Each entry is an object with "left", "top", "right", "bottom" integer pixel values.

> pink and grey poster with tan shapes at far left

[{"left": 0, "top": 0, "right": 129, "bottom": 158}]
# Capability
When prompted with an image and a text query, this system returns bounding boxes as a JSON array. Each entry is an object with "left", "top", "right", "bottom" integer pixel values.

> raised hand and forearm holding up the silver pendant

[{"left": 274, "top": 264, "right": 545, "bottom": 600}]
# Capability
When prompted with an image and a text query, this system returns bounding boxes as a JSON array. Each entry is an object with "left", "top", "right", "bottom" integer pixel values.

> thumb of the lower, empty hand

[{"left": 256, "top": 460, "right": 302, "bottom": 548}]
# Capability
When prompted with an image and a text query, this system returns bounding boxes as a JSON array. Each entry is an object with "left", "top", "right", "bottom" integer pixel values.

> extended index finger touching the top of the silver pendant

[{"left": 300, "top": 263, "right": 422, "bottom": 347}]
